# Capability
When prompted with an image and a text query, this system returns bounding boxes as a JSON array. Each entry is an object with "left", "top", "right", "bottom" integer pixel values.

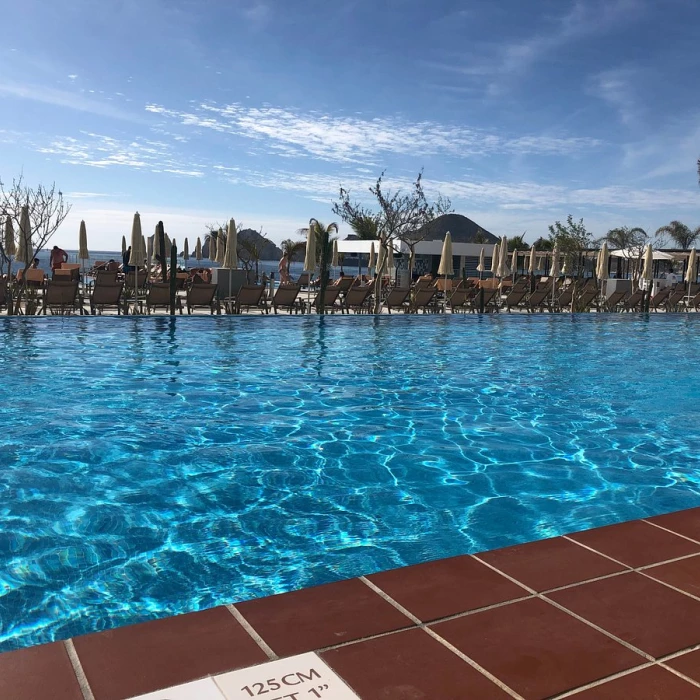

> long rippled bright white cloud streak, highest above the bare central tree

[{"left": 146, "top": 103, "right": 601, "bottom": 164}]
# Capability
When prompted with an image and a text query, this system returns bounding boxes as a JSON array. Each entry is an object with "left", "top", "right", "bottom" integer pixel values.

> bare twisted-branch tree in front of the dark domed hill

[{"left": 333, "top": 171, "right": 452, "bottom": 313}]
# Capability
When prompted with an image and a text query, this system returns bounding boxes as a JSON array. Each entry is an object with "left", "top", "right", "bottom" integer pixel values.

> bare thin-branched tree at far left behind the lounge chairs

[{"left": 0, "top": 175, "right": 71, "bottom": 314}]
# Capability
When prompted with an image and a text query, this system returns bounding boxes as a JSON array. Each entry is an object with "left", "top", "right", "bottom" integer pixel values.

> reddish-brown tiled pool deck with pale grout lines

[{"left": 0, "top": 508, "right": 700, "bottom": 700}]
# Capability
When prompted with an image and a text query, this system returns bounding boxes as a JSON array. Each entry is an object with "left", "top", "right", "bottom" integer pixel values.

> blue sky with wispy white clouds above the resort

[{"left": 0, "top": 0, "right": 700, "bottom": 249}]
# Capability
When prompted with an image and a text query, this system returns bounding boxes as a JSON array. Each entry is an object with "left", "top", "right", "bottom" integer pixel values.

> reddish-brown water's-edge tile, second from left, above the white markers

[{"left": 73, "top": 607, "right": 268, "bottom": 700}]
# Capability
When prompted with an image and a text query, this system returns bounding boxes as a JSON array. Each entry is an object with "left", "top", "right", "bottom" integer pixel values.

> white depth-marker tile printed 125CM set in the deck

[{"left": 214, "top": 652, "right": 360, "bottom": 700}]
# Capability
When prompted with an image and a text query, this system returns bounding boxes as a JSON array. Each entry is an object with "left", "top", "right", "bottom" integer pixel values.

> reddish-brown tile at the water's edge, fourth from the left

[{"left": 367, "top": 556, "right": 530, "bottom": 622}]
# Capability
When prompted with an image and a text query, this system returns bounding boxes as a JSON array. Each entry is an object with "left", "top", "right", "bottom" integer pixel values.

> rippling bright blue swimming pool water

[{"left": 0, "top": 314, "right": 700, "bottom": 649}]
